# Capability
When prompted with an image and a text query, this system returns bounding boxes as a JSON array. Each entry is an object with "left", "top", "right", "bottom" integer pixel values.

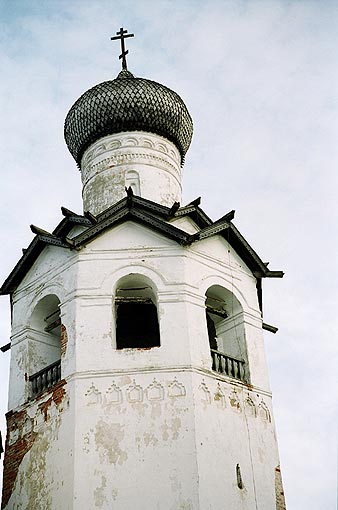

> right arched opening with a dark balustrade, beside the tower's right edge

[{"left": 205, "top": 285, "right": 247, "bottom": 381}]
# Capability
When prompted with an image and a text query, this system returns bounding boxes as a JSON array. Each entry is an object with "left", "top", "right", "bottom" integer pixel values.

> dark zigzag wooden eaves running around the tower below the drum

[{"left": 0, "top": 196, "right": 284, "bottom": 294}]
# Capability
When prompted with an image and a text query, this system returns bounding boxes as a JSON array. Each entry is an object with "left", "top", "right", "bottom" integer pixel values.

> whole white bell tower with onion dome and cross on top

[{"left": 1, "top": 28, "right": 285, "bottom": 510}]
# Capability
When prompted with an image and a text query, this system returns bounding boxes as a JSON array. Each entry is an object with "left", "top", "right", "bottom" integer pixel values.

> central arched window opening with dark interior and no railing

[{"left": 115, "top": 274, "right": 160, "bottom": 349}]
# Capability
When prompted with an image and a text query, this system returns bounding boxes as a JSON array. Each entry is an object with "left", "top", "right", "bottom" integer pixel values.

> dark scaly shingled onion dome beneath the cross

[{"left": 64, "top": 69, "right": 193, "bottom": 166}]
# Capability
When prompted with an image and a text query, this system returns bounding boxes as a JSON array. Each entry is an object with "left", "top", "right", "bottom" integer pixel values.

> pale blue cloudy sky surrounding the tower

[{"left": 0, "top": 0, "right": 338, "bottom": 510}]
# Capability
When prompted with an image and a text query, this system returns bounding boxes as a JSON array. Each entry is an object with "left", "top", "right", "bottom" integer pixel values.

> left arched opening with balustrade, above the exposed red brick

[{"left": 28, "top": 295, "right": 61, "bottom": 396}]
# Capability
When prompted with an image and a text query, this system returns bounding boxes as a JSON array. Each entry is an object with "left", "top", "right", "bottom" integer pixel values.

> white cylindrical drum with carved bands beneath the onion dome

[{"left": 81, "top": 131, "right": 182, "bottom": 215}]
